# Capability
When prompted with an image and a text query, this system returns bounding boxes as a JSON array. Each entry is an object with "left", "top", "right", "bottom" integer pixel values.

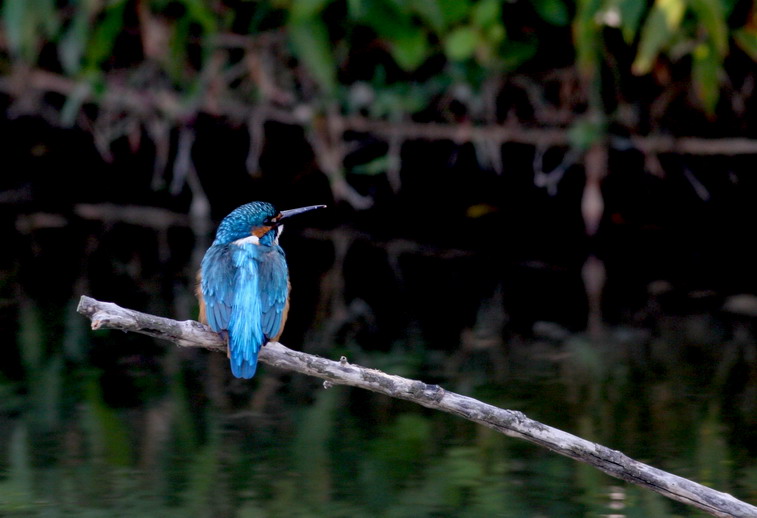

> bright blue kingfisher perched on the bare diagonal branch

[{"left": 197, "top": 201, "right": 326, "bottom": 378}]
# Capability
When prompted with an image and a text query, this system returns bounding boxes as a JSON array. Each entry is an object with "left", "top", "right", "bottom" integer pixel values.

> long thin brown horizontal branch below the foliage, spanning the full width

[{"left": 0, "top": 69, "right": 757, "bottom": 156}]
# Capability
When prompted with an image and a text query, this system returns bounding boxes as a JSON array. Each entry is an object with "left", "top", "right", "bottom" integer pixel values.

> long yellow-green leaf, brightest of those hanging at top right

[{"left": 631, "top": 0, "right": 686, "bottom": 75}]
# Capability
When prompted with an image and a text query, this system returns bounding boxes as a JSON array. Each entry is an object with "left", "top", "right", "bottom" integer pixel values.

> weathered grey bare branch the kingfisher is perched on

[{"left": 77, "top": 296, "right": 757, "bottom": 518}]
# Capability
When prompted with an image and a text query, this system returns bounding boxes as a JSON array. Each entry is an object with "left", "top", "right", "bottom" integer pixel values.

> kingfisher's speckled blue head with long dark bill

[{"left": 214, "top": 201, "right": 325, "bottom": 245}]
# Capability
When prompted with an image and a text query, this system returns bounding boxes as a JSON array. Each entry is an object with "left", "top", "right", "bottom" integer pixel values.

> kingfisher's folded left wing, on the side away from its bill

[{"left": 200, "top": 245, "right": 235, "bottom": 333}]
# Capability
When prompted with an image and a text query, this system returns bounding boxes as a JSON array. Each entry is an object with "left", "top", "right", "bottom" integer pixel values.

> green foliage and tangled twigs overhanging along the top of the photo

[{"left": 0, "top": 0, "right": 757, "bottom": 206}]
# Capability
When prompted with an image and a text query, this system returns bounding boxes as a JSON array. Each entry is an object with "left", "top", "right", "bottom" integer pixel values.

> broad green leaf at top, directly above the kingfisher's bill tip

[{"left": 287, "top": 17, "right": 336, "bottom": 93}]
